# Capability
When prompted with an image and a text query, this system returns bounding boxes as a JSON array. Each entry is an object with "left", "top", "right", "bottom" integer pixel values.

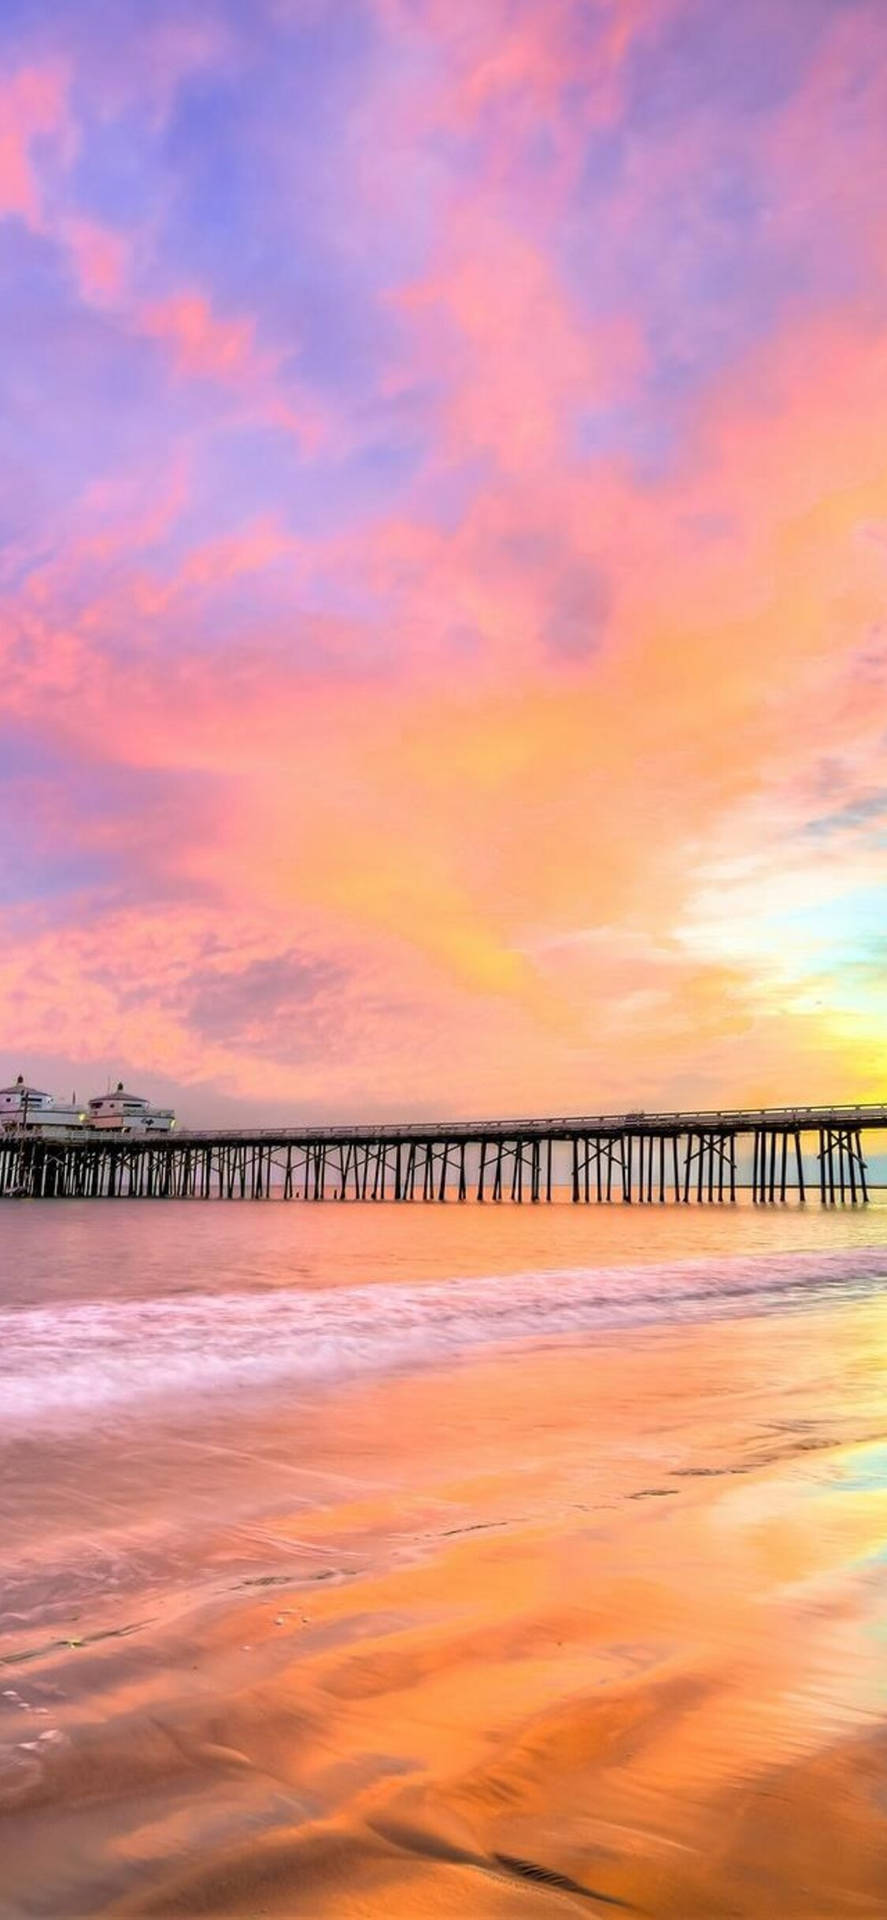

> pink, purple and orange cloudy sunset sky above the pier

[{"left": 0, "top": 0, "right": 887, "bottom": 1123}]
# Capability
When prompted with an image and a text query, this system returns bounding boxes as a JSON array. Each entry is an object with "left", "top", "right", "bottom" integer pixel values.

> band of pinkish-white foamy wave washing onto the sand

[{"left": 0, "top": 1248, "right": 887, "bottom": 1430}]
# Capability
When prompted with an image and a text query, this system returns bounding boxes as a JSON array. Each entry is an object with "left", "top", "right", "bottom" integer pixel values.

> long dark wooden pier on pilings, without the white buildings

[{"left": 0, "top": 1106, "right": 875, "bottom": 1206}]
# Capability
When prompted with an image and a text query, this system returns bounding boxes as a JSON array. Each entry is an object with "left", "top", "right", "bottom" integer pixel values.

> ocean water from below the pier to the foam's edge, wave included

[{"left": 0, "top": 1200, "right": 887, "bottom": 1438}]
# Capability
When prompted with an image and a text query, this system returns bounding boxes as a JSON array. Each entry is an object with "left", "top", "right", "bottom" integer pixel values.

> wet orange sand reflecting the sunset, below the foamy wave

[{"left": 0, "top": 1296, "right": 887, "bottom": 1920}]
